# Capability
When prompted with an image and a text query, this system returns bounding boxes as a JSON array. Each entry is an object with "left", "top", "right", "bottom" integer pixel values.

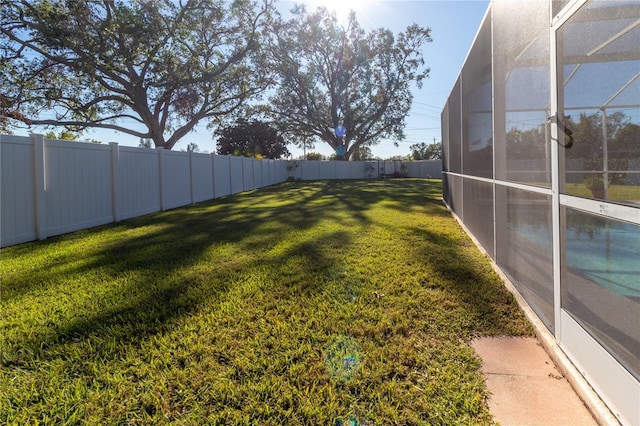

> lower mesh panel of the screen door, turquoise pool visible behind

[{"left": 562, "top": 208, "right": 640, "bottom": 379}]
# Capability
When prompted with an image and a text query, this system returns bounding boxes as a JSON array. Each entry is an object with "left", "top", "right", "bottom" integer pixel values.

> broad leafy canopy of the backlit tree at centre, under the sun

[{"left": 267, "top": 8, "right": 431, "bottom": 160}]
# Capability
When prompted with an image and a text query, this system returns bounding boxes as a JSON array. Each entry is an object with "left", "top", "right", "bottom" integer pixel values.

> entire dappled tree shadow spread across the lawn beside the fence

[{"left": 3, "top": 180, "right": 450, "bottom": 365}]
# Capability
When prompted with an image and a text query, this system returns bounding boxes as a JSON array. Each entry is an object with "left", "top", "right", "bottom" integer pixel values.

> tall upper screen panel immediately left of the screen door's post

[{"left": 493, "top": 0, "right": 551, "bottom": 187}]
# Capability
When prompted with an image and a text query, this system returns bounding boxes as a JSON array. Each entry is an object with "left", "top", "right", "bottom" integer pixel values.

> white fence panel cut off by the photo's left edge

[{"left": 0, "top": 135, "right": 37, "bottom": 247}]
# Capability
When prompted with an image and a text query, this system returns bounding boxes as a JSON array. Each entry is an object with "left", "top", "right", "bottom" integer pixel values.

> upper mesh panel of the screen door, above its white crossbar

[{"left": 557, "top": 1, "right": 640, "bottom": 205}]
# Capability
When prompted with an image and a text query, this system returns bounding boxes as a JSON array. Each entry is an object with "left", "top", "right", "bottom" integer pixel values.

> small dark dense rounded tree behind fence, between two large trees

[{"left": 216, "top": 120, "right": 289, "bottom": 159}]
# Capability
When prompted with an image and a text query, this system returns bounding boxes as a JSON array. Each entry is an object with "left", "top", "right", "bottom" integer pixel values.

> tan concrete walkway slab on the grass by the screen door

[{"left": 472, "top": 337, "right": 598, "bottom": 426}]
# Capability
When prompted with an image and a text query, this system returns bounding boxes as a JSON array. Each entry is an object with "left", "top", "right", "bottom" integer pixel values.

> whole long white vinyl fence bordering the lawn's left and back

[{"left": 0, "top": 135, "right": 442, "bottom": 247}]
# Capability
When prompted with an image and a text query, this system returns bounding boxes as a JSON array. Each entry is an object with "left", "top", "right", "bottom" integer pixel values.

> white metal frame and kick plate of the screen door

[{"left": 550, "top": 0, "right": 640, "bottom": 424}]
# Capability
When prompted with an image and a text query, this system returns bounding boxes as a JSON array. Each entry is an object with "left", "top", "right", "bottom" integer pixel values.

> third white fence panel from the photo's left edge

[{"left": 116, "top": 146, "right": 161, "bottom": 220}]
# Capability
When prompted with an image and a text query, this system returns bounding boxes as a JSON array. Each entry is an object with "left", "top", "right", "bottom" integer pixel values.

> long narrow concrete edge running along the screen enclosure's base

[{"left": 445, "top": 204, "right": 621, "bottom": 426}]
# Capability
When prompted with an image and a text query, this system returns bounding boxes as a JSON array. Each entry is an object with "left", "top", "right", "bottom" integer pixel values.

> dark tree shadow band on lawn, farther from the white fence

[{"left": 0, "top": 225, "right": 350, "bottom": 367}]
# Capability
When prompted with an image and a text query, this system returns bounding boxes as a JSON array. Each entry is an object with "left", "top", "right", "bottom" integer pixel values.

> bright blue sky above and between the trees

[{"left": 16, "top": 0, "right": 489, "bottom": 159}]
